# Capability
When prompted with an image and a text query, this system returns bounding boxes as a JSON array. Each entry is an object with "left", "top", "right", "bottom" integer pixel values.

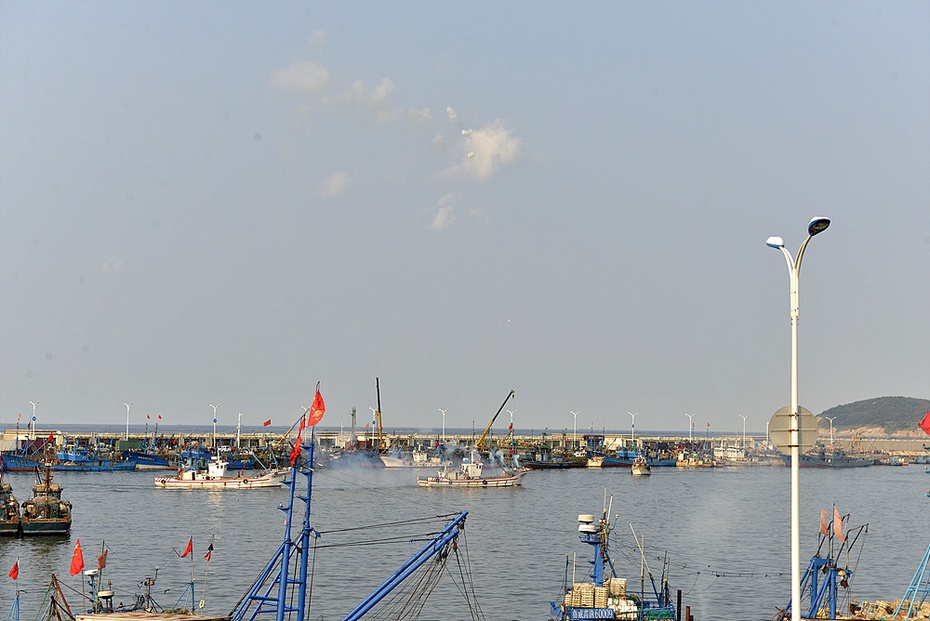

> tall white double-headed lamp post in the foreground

[{"left": 765, "top": 216, "right": 830, "bottom": 621}]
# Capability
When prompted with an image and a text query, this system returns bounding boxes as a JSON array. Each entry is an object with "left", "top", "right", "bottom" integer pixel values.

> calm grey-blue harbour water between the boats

[{"left": 0, "top": 466, "right": 930, "bottom": 621}]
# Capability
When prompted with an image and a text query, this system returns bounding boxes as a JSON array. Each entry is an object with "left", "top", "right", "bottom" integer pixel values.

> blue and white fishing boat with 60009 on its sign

[{"left": 549, "top": 499, "right": 676, "bottom": 621}]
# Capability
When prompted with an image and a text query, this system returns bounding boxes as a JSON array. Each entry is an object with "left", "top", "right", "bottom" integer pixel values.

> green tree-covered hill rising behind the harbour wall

[{"left": 819, "top": 397, "right": 930, "bottom": 434}]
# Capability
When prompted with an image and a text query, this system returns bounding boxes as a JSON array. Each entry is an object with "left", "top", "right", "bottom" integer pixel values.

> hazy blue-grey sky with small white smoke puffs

[{"left": 0, "top": 0, "right": 930, "bottom": 433}]
